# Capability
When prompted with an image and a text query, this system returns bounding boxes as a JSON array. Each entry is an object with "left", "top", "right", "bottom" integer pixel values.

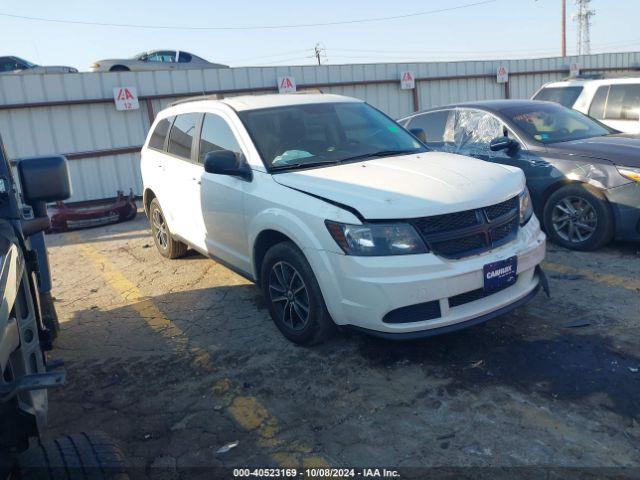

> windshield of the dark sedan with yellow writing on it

[{"left": 502, "top": 103, "right": 614, "bottom": 143}]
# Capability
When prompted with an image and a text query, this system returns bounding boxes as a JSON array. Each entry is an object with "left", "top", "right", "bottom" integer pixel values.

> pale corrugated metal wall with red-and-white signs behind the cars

[{"left": 0, "top": 52, "right": 640, "bottom": 201}]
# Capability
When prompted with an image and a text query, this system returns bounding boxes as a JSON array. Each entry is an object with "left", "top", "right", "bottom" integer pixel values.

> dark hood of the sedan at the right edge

[{"left": 547, "top": 134, "right": 640, "bottom": 167}]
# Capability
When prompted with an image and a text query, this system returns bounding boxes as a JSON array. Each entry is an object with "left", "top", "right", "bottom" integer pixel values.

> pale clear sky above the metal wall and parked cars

[{"left": 0, "top": 0, "right": 640, "bottom": 71}]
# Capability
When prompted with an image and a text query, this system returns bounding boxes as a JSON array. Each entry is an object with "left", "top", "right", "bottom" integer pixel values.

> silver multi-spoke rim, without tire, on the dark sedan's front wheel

[{"left": 551, "top": 196, "right": 598, "bottom": 243}]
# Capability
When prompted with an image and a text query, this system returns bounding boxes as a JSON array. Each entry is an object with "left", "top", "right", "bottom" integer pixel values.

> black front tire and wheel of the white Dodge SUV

[{"left": 260, "top": 241, "right": 336, "bottom": 345}]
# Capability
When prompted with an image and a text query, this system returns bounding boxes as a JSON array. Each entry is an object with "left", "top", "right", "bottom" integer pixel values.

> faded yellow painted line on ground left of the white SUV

[{"left": 66, "top": 233, "right": 329, "bottom": 468}]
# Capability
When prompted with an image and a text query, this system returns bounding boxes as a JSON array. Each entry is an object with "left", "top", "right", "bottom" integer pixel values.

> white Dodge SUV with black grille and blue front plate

[{"left": 142, "top": 94, "right": 546, "bottom": 343}]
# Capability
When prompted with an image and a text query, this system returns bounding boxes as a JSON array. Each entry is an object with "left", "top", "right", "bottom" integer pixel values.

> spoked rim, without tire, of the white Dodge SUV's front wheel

[{"left": 269, "top": 261, "right": 310, "bottom": 330}]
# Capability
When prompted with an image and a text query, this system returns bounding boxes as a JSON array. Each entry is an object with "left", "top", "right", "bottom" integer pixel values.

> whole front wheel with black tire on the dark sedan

[{"left": 543, "top": 184, "right": 614, "bottom": 250}]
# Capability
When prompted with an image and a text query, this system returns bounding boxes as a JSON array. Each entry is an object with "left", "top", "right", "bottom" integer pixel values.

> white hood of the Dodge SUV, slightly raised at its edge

[{"left": 273, "top": 152, "right": 525, "bottom": 219}]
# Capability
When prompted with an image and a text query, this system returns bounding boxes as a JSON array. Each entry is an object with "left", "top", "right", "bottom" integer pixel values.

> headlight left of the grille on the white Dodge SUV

[{"left": 325, "top": 220, "right": 428, "bottom": 256}]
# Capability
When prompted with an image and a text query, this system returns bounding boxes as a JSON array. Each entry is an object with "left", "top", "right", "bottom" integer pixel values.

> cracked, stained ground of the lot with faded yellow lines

[{"left": 42, "top": 215, "right": 640, "bottom": 478}]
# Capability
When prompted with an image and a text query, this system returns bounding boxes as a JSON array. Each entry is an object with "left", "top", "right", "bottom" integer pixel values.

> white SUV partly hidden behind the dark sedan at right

[{"left": 532, "top": 78, "right": 640, "bottom": 134}]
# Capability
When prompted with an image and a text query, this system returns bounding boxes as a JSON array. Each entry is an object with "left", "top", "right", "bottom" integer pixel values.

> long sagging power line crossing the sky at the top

[{"left": 0, "top": 0, "right": 498, "bottom": 30}]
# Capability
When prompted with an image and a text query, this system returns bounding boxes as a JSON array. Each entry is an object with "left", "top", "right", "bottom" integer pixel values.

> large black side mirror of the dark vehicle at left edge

[{"left": 18, "top": 155, "right": 71, "bottom": 206}]
